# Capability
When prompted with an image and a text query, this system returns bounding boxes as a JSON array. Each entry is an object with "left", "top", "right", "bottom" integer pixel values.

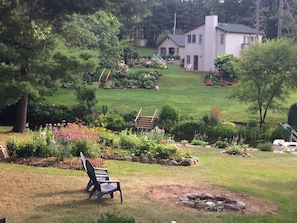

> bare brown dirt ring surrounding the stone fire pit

[{"left": 151, "top": 185, "right": 278, "bottom": 215}]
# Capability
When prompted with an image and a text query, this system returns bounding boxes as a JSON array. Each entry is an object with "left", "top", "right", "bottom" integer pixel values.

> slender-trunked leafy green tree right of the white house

[{"left": 231, "top": 38, "right": 297, "bottom": 127}]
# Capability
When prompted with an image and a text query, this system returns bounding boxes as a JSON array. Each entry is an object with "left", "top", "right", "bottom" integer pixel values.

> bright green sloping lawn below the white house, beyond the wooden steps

[{"left": 44, "top": 66, "right": 297, "bottom": 124}]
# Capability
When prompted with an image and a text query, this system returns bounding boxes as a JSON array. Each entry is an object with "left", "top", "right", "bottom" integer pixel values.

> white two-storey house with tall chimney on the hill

[{"left": 158, "top": 15, "right": 262, "bottom": 71}]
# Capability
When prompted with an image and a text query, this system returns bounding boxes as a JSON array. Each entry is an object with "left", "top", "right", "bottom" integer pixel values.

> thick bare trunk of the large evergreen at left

[{"left": 12, "top": 94, "right": 28, "bottom": 133}]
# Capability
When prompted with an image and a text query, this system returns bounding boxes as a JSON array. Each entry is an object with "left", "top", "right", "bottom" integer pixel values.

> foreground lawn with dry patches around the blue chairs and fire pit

[{"left": 0, "top": 147, "right": 297, "bottom": 223}]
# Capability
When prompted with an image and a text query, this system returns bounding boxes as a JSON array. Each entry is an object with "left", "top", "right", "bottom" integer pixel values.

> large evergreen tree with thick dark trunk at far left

[{"left": 0, "top": 0, "right": 118, "bottom": 132}]
